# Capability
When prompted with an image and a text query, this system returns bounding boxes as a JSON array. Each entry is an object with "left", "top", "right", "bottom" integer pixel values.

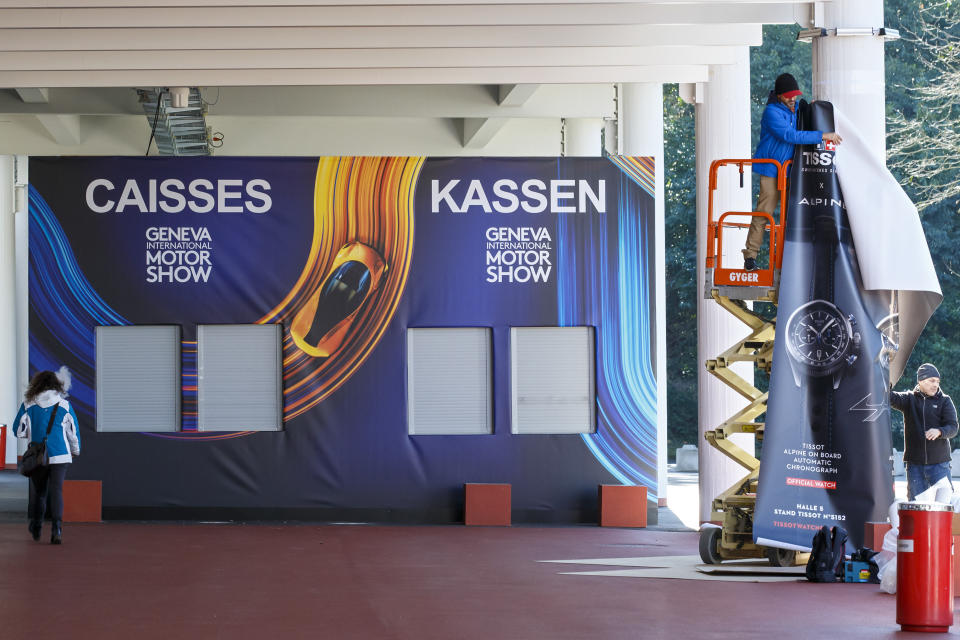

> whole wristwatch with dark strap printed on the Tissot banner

[{"left": 785, "top": 217, "right": 860, "bottom": 431}]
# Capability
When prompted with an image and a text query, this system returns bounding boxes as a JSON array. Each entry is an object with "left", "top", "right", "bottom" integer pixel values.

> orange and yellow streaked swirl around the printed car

[{"left": 257, "top": 157, "right": 424, "bottom": 420}]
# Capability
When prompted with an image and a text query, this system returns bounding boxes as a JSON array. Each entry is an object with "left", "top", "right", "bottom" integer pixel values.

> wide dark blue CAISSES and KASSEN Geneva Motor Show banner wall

[{"left": 29, "top": 157, "right": 658, "bottom": 522}]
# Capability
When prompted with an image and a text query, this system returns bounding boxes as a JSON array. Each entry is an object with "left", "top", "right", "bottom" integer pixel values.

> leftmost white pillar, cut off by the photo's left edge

[{"left": 0, "top": 155, "right": 20, "bottom": 463}]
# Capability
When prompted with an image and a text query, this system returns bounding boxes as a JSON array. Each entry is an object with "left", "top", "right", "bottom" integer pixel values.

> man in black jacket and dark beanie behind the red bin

[{"left": 890, "top": 363, "right": 958, "bottom": 500}]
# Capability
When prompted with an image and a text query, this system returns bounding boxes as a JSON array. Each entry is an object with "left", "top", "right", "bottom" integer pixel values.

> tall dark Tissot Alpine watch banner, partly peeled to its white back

[{"left": 753, "top": 102, "right": 939, "bottom": 550}]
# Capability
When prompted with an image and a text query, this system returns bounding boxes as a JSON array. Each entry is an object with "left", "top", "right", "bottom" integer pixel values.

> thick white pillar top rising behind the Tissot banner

[{"left": 813, "top": 0, "right": 886, "bottom": 163}]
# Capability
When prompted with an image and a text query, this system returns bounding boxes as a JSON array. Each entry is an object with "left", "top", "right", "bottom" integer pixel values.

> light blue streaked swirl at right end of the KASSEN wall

[{"left": 557, "top": 157, "right": 657, "bottom": 494}]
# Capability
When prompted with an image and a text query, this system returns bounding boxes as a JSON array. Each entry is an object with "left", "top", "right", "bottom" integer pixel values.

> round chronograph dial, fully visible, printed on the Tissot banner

[{"left": 787, "top": 300, "right": 853, "bottom": 375}]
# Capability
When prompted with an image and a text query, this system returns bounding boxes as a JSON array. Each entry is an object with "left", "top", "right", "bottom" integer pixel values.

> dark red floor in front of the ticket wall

[{"left": 0, "top": 523, "right": 960, "bottom": 640}]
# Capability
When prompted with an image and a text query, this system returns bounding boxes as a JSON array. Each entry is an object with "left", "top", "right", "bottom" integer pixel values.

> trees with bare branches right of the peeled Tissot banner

[{"left": 886, "top": 0, "right": 960, "bottom": 449}]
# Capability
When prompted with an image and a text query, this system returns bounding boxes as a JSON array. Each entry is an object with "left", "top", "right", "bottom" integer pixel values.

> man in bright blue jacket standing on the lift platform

[{"left": 743, "top": 73, "right": 841, "bottom": 271}]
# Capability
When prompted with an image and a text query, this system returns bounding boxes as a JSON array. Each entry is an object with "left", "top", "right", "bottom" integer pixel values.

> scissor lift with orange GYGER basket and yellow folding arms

[{"left": 700, "top": 159, "right": 807, "bottom": 566}]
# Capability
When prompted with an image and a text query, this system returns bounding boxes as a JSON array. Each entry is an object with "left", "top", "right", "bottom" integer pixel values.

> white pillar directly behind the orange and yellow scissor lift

[{"left": 690, "top": 47, "right": 754, "bottom": 522}]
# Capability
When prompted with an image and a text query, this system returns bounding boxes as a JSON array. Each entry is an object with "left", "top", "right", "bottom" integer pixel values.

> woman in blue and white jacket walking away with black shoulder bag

[{"left": 13, "top": 367, "right": 80, "bottom": 544}]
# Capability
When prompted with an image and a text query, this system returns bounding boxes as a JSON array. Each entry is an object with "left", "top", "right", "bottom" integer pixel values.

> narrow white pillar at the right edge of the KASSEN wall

[{"left": 619, "top": 82, "right": 667, "bottom": 506}]
